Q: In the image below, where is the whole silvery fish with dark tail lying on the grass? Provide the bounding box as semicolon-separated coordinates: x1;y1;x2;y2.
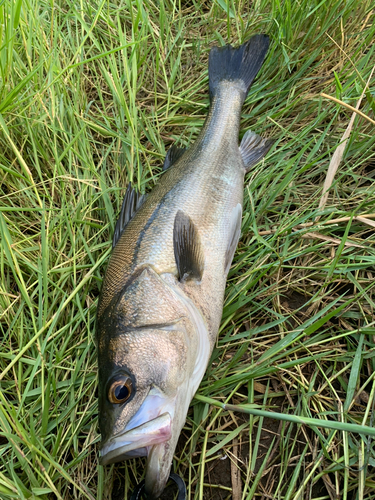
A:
96;34;273;500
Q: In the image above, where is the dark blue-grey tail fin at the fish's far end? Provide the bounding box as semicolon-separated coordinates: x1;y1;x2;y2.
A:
208;35;269;99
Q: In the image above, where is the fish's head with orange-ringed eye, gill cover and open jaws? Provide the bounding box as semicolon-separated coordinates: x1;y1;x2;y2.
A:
97;270;203;498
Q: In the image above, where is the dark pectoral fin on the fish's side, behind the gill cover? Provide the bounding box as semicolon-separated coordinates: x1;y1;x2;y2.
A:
173;210;204;282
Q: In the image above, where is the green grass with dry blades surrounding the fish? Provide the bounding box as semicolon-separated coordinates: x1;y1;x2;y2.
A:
0;0;375;500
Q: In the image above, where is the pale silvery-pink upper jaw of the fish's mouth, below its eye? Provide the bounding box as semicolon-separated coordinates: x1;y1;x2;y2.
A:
100;412;172;465
